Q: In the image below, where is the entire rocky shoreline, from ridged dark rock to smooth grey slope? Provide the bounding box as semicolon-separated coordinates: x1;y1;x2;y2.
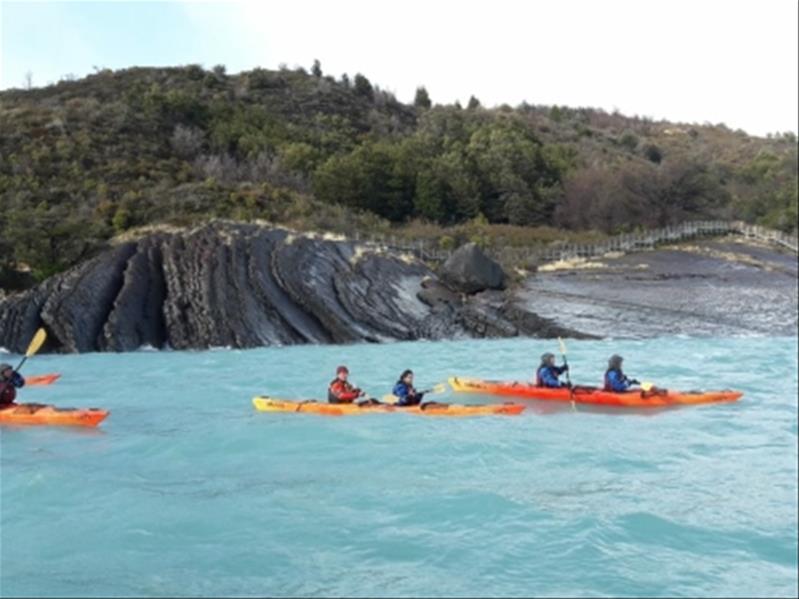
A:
0;222;797;353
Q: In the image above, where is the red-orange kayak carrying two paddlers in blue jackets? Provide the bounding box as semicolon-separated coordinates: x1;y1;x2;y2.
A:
449;377;743;408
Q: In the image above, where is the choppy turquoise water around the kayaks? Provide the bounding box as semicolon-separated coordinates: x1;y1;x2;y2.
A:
0;338;797;597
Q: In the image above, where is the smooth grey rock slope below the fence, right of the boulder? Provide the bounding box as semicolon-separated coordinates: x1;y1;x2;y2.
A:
517;238;799;338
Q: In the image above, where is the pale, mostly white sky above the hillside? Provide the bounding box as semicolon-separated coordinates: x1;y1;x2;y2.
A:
0;0;799;135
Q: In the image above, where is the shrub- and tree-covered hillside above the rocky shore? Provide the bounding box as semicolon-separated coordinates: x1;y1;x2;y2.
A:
0;64;797;286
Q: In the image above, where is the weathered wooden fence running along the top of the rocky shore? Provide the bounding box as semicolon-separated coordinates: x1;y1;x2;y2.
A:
355;221;797;264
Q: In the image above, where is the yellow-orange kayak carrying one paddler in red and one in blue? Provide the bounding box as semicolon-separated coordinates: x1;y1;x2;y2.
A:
252;397;525;416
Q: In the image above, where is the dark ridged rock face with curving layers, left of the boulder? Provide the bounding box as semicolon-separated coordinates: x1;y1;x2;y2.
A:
0;223;588;352
